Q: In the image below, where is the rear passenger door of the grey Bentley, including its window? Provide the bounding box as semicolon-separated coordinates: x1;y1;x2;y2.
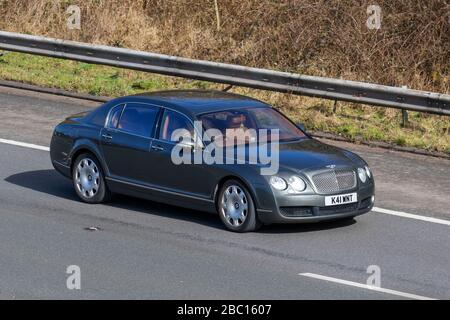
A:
101;103;160;183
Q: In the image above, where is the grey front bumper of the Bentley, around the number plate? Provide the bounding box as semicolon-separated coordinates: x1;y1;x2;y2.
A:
257;184;375;224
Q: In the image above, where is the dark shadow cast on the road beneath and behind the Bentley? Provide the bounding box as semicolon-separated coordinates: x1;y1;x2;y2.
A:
5;170;355;233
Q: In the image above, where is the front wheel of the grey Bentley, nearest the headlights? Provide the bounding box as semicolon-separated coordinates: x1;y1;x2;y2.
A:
217;180;262;232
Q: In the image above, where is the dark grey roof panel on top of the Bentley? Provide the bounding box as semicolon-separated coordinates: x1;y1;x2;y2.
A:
123;90;270;117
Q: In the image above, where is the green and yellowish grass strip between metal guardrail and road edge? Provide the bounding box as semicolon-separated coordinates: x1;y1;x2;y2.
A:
0;52;450;154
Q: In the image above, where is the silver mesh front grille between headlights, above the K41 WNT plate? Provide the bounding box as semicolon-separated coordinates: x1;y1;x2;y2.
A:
311;169;356;193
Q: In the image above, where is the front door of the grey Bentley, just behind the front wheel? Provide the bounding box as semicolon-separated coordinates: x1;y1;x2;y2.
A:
150;109;217;198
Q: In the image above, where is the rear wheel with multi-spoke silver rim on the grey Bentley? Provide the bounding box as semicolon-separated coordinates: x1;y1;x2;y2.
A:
72;153;111;203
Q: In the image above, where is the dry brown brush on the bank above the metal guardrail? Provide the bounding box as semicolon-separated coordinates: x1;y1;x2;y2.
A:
0;0;450;92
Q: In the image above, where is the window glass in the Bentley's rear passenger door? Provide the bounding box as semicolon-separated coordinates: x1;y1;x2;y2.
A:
117;103;159;137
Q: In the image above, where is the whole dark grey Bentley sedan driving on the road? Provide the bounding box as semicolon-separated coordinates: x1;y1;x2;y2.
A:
50;90;375;232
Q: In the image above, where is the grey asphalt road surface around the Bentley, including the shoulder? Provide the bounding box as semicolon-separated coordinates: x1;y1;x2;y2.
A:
0;88;450;299
